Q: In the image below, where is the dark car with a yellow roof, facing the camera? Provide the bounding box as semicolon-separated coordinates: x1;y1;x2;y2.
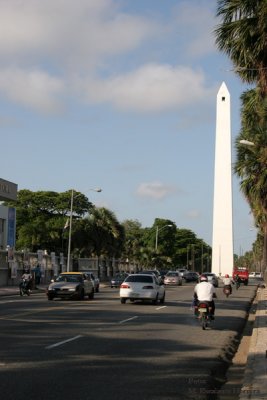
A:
46;272;95;300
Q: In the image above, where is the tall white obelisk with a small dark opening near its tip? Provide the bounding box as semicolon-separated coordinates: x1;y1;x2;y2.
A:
212;82;234;276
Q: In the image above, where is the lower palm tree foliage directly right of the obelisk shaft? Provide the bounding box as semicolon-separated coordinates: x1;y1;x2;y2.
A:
237;90;267;269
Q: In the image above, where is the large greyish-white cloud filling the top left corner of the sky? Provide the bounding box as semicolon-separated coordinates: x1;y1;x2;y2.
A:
0;0;159;67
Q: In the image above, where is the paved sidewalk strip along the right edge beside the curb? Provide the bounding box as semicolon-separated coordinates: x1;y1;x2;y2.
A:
239;288;267;400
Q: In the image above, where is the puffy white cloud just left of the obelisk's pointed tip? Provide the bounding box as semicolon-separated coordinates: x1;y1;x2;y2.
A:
87;64;216;112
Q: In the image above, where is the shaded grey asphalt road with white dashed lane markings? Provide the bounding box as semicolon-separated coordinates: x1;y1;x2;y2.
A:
0;284;256;400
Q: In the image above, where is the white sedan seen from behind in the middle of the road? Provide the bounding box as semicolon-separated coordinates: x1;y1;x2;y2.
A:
120;273;165;304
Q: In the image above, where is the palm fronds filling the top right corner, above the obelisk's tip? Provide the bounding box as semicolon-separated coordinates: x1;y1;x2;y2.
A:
215;0;267;97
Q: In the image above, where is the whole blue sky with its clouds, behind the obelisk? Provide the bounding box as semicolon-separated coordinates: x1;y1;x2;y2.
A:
0;0;256;255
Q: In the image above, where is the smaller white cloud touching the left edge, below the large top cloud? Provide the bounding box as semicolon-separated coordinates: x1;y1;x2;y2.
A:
0;68;64;113
